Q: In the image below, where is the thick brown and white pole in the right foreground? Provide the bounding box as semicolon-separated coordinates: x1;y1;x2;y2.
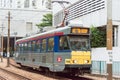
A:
107;0;113;80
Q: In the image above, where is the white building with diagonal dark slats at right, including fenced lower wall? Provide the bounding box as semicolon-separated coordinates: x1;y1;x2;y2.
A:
54;0;120;76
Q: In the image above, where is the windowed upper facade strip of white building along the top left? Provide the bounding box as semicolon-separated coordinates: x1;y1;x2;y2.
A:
0;0;51;10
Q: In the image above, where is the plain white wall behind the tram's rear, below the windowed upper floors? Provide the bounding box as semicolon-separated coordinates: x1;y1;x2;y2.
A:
0;9;51;37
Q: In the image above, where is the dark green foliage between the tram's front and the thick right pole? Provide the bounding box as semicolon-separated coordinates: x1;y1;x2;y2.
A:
91;26;106;48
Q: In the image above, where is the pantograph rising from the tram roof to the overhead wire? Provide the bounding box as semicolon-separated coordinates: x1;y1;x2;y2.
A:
52;0;70;27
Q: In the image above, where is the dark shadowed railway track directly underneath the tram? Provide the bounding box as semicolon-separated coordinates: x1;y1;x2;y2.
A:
11;64;93;80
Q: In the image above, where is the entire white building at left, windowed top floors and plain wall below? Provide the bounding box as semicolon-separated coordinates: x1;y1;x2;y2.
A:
0;0;51;51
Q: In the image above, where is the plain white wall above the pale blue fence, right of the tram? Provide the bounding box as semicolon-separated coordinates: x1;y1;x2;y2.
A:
92;47;120;61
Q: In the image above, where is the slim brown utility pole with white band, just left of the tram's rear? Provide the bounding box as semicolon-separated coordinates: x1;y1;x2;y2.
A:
7;11;10;67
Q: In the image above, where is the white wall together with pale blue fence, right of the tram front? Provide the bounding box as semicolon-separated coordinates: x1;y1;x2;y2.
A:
92;47;120;77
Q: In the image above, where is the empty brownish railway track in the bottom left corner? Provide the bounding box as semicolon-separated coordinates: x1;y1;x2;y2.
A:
0;68;31;80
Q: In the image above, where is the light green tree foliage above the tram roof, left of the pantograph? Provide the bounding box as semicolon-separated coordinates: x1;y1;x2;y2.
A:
36;14;52;28
